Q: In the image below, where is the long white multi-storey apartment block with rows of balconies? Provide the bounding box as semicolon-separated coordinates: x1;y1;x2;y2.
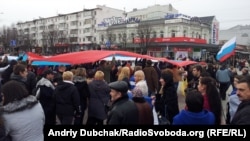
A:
17;5;124;54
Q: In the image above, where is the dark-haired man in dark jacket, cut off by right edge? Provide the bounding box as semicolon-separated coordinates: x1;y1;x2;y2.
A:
231;75;250;125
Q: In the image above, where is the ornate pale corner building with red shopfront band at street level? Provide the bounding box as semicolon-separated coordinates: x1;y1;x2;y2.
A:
98;5;219;59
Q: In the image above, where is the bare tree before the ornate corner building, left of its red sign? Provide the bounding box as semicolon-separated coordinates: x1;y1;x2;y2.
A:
137;21;152;54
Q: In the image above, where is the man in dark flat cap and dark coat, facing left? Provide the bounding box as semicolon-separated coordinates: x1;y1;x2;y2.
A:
107;81;139;125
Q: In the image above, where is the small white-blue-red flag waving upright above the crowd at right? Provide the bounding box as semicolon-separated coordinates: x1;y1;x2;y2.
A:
216;37;236;62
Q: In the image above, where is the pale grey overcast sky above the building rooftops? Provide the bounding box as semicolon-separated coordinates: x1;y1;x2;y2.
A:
0;0;250;29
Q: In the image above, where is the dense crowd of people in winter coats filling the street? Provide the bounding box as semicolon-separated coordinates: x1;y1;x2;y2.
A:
0;55;250;141
